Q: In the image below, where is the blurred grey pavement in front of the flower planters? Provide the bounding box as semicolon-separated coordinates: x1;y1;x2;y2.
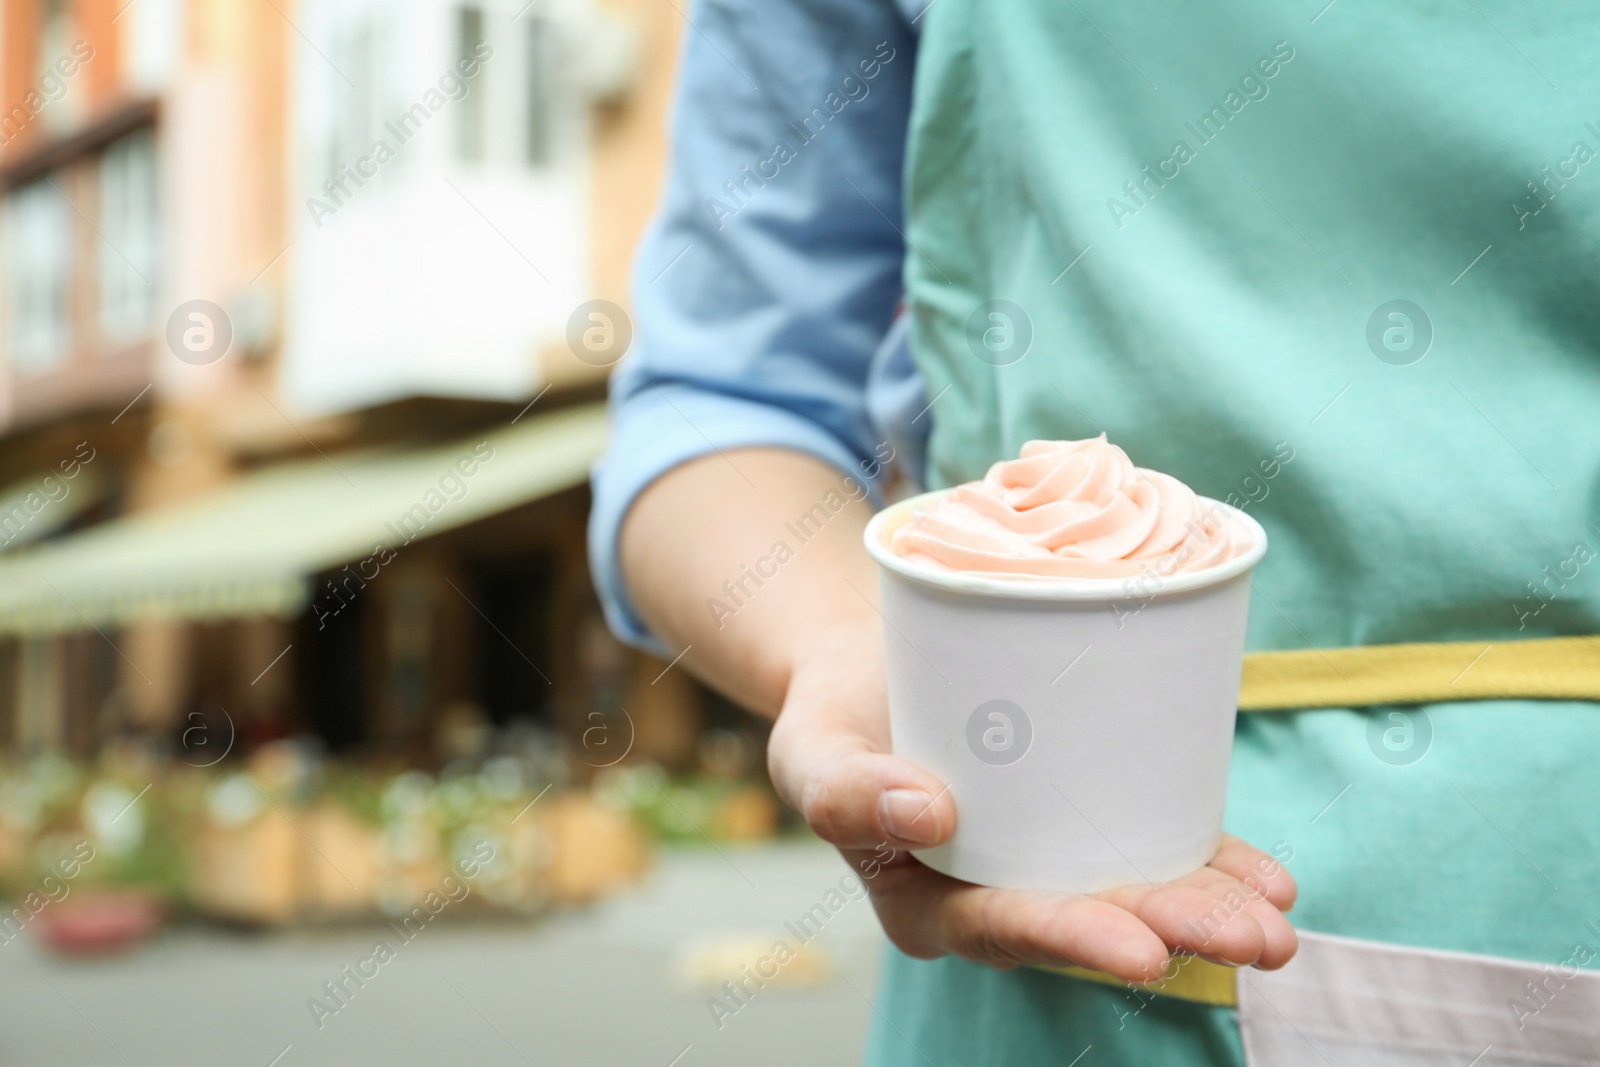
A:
0;843;882;1067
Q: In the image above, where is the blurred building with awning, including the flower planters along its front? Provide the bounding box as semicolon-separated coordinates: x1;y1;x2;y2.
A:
0;0;790;947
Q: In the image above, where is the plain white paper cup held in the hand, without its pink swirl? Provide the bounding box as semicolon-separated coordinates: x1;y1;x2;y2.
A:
866;493;1267;893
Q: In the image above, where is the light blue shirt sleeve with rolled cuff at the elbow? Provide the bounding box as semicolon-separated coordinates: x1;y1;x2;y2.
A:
589;0;915;656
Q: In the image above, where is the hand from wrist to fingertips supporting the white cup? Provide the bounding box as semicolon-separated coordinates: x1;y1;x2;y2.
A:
768;621;1298;982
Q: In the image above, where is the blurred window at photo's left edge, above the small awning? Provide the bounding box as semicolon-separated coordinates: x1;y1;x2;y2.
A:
5;178;72;374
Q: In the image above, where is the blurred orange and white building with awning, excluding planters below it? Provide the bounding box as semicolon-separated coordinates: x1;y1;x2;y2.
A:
0;0;698;761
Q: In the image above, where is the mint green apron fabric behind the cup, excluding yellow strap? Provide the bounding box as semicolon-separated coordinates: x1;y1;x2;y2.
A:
867;0;1600;1067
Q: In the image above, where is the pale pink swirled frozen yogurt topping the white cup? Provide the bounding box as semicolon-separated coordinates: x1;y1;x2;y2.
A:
890;434;1253;577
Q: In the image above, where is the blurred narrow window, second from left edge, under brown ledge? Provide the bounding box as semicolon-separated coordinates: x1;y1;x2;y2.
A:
99;128;157;341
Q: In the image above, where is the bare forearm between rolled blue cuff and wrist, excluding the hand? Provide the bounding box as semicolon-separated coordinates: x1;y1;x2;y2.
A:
619;448;880;715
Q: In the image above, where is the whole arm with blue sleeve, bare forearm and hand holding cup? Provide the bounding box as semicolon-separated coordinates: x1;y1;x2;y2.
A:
592;0;1294;981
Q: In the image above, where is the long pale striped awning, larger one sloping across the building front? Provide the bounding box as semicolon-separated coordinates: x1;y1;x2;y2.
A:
0;405;605;633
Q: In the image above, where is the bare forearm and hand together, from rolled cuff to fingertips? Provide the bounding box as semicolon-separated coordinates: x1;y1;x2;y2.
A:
621;448;1296;982
